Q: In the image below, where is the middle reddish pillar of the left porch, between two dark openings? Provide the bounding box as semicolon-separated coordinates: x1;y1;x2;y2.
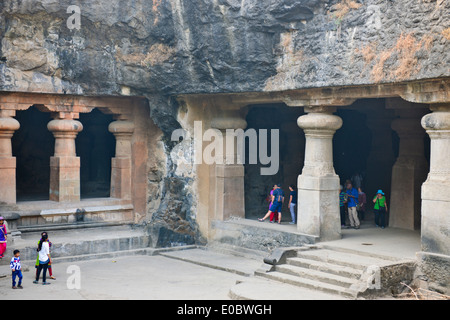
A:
47;113;83;202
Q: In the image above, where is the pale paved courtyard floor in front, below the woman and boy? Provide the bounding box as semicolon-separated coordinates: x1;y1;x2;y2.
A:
0;256;248;300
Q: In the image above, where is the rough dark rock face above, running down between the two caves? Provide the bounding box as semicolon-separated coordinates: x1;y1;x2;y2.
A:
0;0;450;242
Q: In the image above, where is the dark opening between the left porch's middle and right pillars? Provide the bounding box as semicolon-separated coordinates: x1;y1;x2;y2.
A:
75;109;116;198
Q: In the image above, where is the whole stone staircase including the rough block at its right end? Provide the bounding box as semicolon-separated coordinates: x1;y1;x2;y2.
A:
255;245;414;299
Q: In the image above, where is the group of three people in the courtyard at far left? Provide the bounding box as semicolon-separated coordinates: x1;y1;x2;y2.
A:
0;217;56;289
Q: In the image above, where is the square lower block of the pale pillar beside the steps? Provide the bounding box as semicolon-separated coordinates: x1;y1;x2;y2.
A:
297;175;341;241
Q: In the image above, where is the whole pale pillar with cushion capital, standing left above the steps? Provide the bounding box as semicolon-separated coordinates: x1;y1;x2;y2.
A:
297;107;342;241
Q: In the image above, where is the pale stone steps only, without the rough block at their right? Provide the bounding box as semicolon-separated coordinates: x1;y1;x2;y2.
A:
255;246;410;299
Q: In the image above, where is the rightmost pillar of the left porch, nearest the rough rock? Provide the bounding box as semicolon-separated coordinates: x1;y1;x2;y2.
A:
108;120;134;199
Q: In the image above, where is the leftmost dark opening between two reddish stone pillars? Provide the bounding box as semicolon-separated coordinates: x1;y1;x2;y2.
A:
11;106;55;201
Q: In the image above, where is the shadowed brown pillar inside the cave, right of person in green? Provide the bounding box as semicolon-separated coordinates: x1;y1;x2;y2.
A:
389;108;428;230
